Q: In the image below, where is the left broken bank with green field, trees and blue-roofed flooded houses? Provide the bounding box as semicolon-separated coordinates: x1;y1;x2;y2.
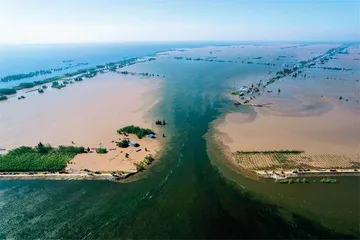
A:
0;125;165;181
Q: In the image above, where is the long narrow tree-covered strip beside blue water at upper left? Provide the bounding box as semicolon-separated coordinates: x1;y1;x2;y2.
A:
0;58;164;101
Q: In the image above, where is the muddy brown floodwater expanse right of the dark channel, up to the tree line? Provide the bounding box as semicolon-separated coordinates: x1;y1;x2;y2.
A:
215;43;360;174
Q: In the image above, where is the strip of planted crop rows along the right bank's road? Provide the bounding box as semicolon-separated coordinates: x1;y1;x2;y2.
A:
234;150;360;170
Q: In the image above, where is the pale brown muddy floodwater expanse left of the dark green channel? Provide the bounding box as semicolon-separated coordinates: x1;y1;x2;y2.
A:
0;73;163;172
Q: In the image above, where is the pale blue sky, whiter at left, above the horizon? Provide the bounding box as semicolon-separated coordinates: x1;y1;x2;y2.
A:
0;0;360;44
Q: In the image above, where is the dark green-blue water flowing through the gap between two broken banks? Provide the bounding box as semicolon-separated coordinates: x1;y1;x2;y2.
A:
0;45;359;239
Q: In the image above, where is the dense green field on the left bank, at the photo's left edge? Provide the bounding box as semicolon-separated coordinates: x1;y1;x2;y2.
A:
0;142;84;172
